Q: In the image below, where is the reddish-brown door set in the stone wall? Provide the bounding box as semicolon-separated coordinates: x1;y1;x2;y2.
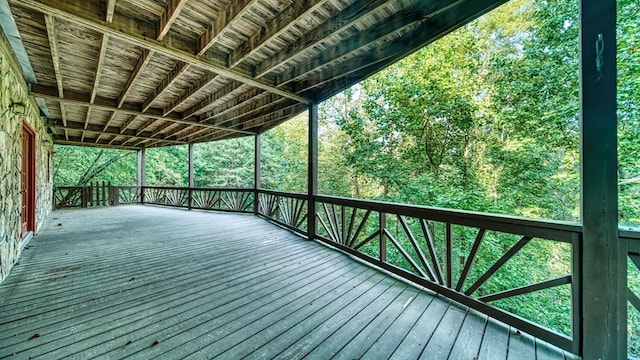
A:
20;124;36;236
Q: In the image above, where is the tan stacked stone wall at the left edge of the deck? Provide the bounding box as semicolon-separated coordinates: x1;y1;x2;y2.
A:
0;31;53;282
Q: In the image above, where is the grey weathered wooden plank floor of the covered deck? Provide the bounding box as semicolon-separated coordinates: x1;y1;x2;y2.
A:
0;206;572;359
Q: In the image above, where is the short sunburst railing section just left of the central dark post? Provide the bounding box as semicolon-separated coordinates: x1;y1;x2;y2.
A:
258;190;308;235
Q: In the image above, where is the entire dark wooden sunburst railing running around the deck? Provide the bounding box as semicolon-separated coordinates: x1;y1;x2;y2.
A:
55;186;640;353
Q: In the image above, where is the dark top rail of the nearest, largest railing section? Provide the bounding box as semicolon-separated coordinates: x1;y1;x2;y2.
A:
316;195;582;242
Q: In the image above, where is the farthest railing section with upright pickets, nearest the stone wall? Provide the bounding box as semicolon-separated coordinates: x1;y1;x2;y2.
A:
53;181;117;209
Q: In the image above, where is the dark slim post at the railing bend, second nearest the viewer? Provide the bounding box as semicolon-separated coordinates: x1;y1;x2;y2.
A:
307;104;318;240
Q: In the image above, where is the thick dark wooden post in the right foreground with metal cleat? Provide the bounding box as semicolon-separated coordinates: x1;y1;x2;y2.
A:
580;0;627;360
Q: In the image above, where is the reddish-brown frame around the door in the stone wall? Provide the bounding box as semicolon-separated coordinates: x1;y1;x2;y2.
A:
20;121;36;237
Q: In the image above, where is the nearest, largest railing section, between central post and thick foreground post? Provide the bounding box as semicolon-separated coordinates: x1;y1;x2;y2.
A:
315;196;582;353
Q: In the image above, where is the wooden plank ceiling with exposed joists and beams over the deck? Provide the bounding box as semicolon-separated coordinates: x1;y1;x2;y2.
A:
9;0;506;149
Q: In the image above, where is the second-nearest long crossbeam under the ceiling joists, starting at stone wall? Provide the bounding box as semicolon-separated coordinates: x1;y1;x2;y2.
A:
30;84;253;135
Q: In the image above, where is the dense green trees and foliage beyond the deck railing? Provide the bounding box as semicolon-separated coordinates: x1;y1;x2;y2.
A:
55;0;640;355
